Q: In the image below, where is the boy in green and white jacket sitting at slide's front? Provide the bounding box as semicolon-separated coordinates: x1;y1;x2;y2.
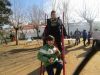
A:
38;35;63;75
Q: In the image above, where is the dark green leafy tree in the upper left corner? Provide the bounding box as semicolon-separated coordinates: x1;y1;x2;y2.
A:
0;0;12;25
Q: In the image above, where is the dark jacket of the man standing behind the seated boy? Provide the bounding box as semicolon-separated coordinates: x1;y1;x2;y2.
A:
44;18;67;42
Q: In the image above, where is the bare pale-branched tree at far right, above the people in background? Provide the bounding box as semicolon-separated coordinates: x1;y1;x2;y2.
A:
78;1;98;32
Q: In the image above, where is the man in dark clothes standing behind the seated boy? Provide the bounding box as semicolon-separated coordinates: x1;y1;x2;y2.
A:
44;10;67;53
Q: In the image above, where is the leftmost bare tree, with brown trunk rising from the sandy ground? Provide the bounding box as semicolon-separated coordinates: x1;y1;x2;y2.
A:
10;2;24;45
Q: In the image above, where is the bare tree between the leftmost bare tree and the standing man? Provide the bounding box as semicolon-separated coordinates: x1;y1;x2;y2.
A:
29;5;45;38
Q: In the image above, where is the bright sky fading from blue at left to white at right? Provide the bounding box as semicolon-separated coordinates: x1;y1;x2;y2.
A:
10;0;100;21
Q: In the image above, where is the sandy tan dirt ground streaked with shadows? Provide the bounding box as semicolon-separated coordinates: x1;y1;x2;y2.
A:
0;41;100;75
